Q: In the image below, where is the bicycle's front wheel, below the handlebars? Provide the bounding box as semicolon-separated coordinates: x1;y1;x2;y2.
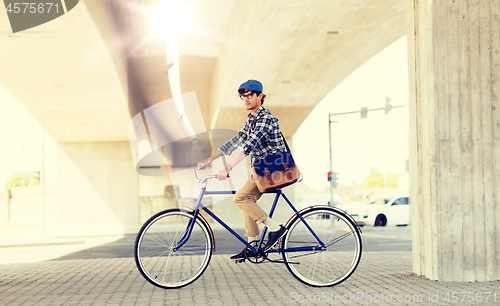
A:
134;209;213;289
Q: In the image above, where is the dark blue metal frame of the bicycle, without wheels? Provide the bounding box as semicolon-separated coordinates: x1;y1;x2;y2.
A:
173;185;327;253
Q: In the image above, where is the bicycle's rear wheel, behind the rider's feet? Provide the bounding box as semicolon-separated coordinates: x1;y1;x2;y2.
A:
282;207;361;287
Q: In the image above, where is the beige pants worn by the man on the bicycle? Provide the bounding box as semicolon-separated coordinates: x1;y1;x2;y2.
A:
233;176;267;237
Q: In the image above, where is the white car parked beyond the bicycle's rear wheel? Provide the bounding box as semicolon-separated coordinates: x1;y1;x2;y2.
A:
339;195;411;226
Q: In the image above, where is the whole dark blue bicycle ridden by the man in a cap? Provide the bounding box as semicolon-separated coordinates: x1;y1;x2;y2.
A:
134;169;362;289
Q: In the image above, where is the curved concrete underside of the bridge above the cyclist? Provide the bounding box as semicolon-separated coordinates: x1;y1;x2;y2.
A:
0;0;405;142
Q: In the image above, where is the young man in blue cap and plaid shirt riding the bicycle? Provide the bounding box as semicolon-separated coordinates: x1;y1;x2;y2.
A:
198;80;287;259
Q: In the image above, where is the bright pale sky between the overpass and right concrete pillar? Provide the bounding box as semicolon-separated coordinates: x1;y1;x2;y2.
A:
293;36;409;190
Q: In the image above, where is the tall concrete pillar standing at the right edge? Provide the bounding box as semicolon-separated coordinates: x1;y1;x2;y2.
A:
407;0;500;281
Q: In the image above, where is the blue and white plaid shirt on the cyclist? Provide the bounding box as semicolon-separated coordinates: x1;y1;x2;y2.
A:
219;105;286;163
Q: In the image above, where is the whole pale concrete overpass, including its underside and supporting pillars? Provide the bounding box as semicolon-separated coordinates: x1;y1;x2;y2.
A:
0;0;500;280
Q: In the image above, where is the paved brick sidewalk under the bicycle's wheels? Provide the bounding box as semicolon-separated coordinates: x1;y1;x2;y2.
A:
0;252;500;305
